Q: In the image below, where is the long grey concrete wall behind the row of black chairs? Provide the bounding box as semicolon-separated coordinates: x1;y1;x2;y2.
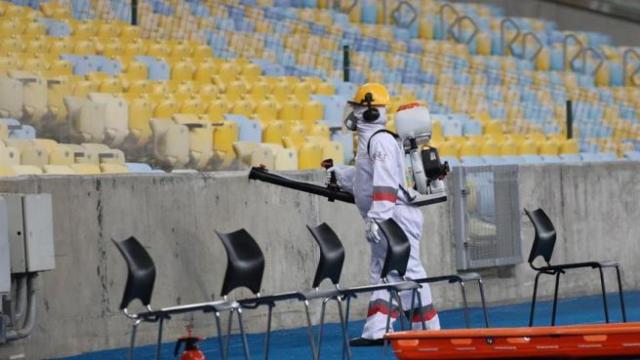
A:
0;163;640;359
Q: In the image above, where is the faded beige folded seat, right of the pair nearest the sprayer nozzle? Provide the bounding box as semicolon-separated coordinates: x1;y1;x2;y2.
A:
172;114;213;169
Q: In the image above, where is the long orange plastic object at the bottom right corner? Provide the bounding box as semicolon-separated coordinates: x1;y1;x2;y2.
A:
386;322;640;360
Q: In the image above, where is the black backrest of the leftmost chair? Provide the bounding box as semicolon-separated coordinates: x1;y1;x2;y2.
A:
114;236;156;310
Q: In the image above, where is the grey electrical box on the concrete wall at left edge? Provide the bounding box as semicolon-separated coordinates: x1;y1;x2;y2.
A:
0;194;55;273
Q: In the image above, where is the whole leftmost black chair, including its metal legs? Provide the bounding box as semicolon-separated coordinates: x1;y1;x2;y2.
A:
114;237;228;359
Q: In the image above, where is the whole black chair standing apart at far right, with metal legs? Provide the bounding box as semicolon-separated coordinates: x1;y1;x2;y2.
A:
524;209;627;326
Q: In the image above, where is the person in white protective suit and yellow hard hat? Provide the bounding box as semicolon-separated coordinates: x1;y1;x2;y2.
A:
328;83;440;346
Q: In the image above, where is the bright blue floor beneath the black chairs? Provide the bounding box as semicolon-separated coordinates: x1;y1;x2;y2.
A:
58;291;640;360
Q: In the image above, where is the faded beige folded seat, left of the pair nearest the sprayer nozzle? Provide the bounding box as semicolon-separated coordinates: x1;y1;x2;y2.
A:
151;119;189;167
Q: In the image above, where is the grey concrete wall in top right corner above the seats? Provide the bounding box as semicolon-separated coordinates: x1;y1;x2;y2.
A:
456;0;640;46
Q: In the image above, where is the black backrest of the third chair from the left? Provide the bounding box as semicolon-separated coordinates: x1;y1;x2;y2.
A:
307;223;344;288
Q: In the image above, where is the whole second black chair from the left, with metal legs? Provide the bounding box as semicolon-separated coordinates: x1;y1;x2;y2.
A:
216;229;347;359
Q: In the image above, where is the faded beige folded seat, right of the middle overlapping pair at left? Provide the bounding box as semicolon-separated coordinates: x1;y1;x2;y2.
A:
88;93;129;146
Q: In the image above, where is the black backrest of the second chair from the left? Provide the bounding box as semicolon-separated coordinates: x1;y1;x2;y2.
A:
216;229;264;296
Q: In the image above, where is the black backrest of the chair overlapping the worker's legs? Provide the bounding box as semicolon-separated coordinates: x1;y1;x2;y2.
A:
378;218;411;278
